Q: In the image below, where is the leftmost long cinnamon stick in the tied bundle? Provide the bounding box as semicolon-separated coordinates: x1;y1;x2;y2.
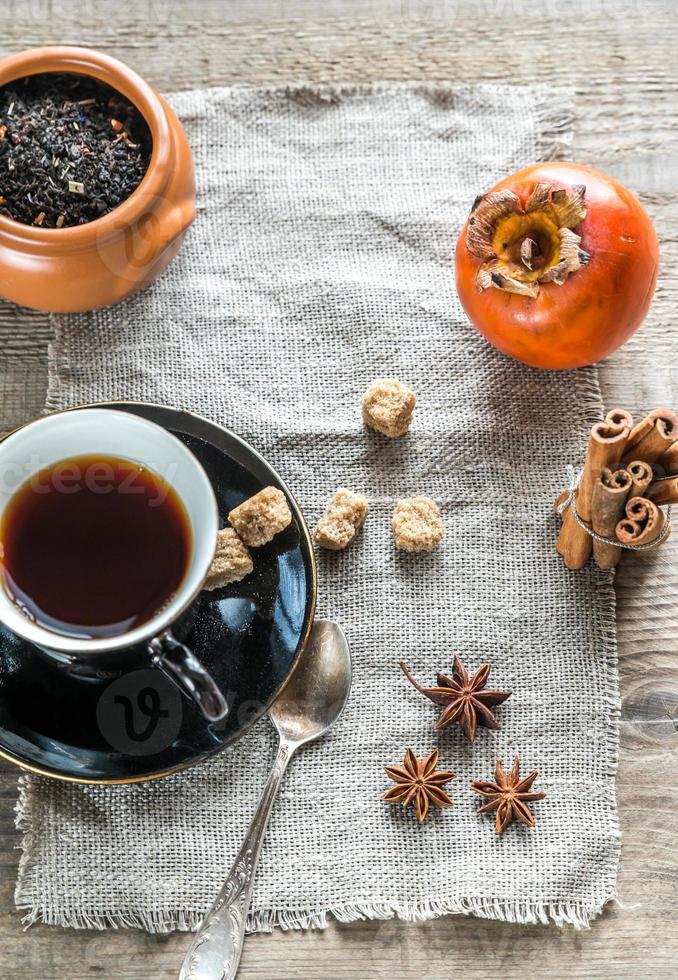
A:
556;421;629;569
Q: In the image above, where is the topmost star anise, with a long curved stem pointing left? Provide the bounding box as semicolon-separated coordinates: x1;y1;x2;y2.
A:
400;656;513;742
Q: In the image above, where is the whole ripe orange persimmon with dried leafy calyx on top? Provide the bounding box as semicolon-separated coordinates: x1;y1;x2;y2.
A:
456;162;659;369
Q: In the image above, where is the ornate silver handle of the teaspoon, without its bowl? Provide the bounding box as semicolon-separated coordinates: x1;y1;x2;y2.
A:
179;742;294;980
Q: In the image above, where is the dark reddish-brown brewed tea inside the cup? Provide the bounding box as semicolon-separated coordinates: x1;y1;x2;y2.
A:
0;455;191;639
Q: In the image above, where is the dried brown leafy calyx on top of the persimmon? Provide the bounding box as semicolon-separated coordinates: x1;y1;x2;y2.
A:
466;181;591;299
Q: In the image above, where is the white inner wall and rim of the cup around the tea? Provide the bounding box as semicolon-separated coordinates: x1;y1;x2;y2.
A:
0;408;219;653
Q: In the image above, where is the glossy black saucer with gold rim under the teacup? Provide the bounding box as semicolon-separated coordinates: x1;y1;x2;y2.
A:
0;402;316;783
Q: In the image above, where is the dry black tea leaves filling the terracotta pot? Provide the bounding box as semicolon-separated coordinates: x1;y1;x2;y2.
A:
0;73;151;228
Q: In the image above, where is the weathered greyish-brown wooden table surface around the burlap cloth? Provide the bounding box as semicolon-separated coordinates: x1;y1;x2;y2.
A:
0;0;678;980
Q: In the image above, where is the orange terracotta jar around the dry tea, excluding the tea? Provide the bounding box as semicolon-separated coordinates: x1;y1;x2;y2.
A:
0;47;195;313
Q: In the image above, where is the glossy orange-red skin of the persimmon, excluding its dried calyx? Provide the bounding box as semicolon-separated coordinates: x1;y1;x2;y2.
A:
456;163;659;370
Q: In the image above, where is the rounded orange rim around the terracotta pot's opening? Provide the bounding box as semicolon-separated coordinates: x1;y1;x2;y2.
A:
0;44;171;251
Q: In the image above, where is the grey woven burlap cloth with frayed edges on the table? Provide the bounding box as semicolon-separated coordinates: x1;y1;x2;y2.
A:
16;84;619;931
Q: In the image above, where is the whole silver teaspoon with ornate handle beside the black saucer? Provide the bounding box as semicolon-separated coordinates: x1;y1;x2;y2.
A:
179;619;351;980
